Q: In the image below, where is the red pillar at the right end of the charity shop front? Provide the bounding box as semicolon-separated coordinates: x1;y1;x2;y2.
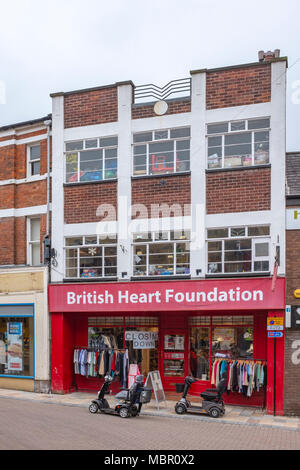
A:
266;311;284;416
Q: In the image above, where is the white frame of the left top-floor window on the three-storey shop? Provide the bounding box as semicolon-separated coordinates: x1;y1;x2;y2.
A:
64;135;119;185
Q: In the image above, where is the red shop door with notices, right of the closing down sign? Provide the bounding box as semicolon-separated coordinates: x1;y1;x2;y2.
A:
160;328;188;391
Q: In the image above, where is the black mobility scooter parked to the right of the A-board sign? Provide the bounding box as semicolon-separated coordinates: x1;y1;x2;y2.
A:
175;373;227;418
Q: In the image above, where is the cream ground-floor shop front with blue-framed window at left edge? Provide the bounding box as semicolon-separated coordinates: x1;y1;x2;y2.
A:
0;267;50;392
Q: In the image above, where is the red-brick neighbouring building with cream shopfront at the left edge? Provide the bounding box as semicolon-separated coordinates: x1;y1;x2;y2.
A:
0;116;51;392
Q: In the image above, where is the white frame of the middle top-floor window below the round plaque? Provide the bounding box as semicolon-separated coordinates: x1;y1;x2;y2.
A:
131;126;191;178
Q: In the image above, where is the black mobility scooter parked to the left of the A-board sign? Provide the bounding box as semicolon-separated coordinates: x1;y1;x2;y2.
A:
89;375;152;418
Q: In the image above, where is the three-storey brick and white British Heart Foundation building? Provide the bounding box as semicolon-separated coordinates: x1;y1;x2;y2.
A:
49;51;287;414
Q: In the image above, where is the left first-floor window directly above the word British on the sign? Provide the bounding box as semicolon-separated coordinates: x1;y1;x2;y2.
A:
65;235;117;279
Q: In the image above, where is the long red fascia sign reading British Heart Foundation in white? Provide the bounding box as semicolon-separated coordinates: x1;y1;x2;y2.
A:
49;278;285;313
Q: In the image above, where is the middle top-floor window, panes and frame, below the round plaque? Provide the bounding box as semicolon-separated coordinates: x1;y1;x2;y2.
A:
133;127;190;176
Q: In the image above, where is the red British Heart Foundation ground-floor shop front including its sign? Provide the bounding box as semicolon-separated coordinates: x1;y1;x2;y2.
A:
49;278;285;414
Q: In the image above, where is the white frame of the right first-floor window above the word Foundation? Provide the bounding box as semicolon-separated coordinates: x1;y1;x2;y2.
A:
206;224;271;276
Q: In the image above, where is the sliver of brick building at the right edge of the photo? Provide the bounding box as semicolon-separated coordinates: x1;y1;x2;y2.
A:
284;152;300;415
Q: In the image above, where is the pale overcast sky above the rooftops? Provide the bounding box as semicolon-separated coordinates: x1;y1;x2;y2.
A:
0;0;300;151
